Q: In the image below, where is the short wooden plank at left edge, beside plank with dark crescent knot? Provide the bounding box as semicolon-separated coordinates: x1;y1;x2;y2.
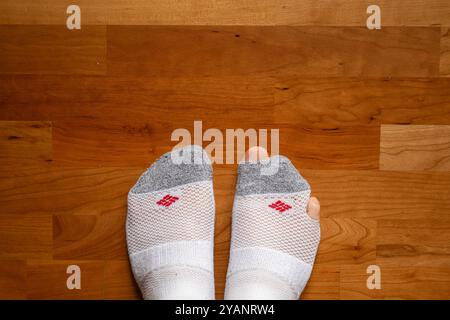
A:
0;214;52;260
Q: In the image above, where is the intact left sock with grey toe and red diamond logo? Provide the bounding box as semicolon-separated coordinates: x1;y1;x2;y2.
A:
126;146;214;300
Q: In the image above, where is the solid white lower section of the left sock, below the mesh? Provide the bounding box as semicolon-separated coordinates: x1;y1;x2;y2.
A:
130;241;214;300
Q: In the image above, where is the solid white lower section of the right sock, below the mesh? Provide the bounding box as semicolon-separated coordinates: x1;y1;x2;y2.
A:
225;247;312;300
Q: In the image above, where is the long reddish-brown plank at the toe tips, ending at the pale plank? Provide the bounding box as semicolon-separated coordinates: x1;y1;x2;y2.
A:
53;119;379;169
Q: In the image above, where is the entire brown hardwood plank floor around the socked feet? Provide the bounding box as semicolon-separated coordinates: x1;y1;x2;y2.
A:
0;0;450;299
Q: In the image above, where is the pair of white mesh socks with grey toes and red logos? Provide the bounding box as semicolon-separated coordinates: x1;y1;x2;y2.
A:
126;146;320;300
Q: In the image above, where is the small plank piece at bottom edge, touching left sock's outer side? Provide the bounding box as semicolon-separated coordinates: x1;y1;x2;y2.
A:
104;260;142;300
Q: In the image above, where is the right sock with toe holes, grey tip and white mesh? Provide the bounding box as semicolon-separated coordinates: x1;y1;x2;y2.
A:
225;156;320;300
